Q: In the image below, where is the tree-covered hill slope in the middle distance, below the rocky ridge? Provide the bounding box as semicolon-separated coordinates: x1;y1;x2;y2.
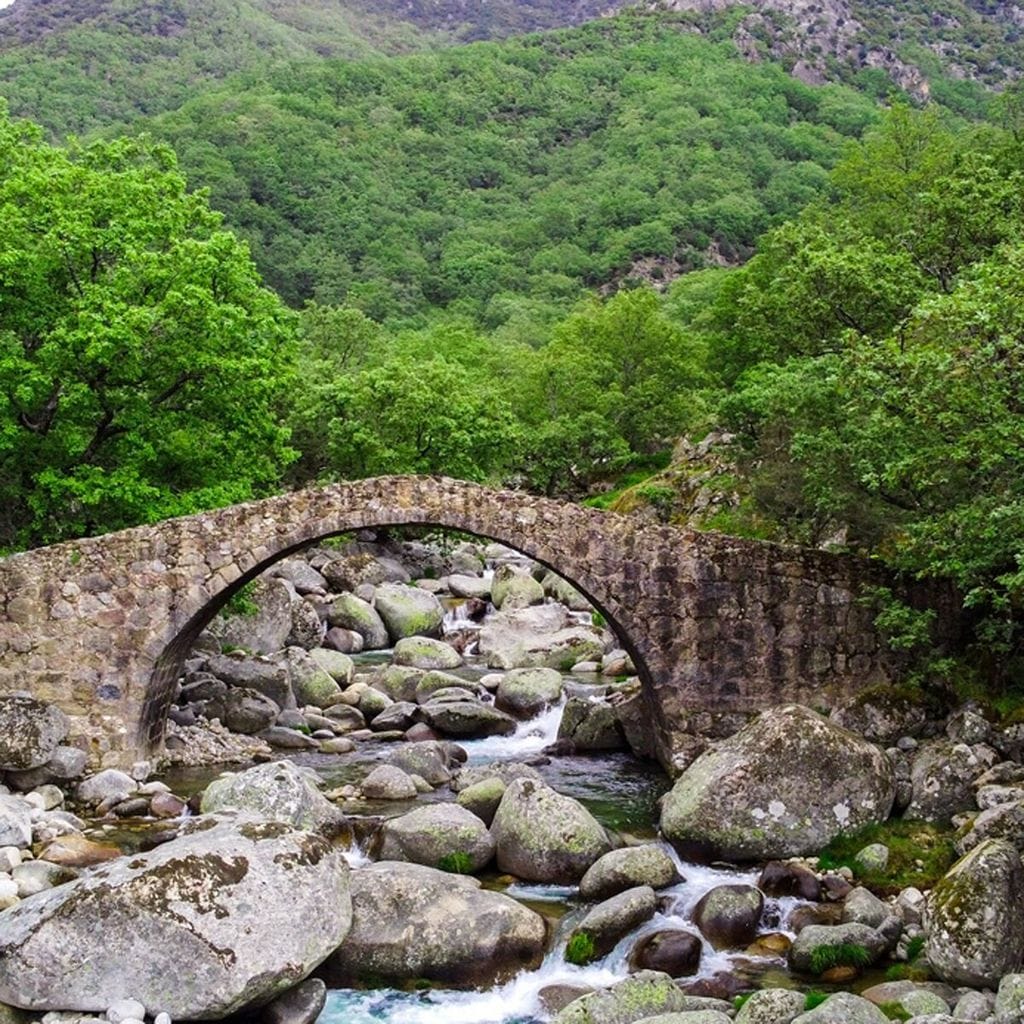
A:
147;16;876;315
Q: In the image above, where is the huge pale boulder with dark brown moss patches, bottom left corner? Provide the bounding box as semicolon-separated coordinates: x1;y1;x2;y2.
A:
0;819;352;1020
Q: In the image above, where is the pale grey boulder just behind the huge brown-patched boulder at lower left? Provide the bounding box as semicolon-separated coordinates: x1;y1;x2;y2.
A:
201;761;343;833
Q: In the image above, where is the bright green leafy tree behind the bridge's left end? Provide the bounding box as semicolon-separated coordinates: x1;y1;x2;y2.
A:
0;109;293;549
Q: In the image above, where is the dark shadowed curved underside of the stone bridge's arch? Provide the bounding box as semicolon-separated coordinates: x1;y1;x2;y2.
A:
137;520;652;753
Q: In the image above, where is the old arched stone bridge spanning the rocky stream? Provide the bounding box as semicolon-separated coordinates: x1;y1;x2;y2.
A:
0;476;950;766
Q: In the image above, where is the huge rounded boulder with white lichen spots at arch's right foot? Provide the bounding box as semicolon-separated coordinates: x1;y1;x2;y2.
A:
662;705;895;860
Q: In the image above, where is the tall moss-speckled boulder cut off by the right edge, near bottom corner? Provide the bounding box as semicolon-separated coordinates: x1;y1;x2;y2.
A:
925;840;1024;988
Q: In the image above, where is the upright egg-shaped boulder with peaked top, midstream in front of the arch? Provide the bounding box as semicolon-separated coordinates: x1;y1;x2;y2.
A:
490;778;611;884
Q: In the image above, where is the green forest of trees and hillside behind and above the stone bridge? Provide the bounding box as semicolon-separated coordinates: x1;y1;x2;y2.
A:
0;5;1024;679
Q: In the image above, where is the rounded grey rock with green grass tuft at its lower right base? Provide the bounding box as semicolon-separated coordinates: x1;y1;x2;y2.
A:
380;804;495;873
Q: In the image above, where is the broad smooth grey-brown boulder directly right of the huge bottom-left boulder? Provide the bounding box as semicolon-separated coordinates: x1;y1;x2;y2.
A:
325;861;546;985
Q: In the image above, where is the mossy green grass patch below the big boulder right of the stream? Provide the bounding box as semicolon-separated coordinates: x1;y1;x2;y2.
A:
819;818;956;895
